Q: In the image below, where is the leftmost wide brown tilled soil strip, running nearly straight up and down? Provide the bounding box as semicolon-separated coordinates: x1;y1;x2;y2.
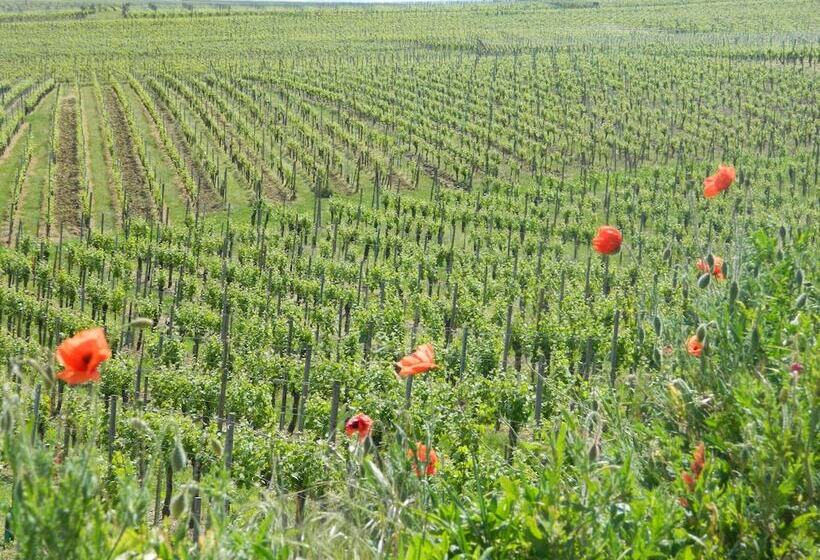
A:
54;97;83;234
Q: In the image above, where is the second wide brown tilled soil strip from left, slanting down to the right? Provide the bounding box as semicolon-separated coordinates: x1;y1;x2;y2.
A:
104;88;154;220
